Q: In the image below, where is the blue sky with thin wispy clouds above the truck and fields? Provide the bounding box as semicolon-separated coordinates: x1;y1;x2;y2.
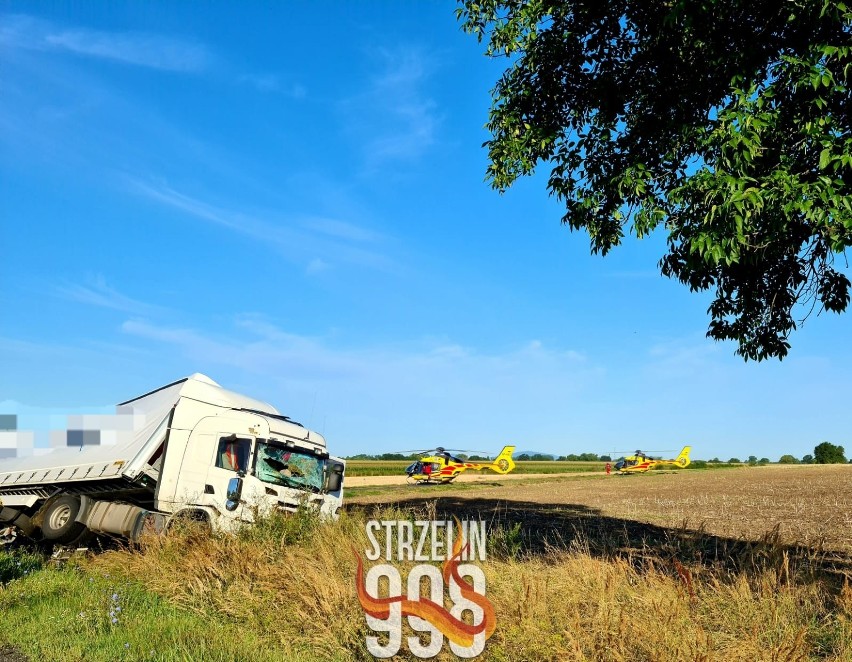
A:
0;1;852;459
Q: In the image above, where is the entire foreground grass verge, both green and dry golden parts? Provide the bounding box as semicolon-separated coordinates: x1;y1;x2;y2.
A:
0;477;852;662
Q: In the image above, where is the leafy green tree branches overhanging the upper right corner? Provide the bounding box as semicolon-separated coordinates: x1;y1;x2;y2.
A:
456;0;852;360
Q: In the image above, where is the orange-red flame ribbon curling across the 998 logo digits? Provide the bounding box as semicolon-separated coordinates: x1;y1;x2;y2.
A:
352;519;497;647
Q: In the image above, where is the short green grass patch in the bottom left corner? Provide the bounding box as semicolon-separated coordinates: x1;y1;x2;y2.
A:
0;550;304;662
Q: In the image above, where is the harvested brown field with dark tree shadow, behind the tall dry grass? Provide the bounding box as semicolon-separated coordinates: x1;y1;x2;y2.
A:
346;465;852;572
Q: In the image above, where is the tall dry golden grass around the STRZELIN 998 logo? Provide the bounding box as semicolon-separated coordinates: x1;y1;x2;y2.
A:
89;508;852;662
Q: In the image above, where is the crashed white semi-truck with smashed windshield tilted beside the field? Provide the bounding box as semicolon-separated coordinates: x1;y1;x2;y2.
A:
0;373;345;545
